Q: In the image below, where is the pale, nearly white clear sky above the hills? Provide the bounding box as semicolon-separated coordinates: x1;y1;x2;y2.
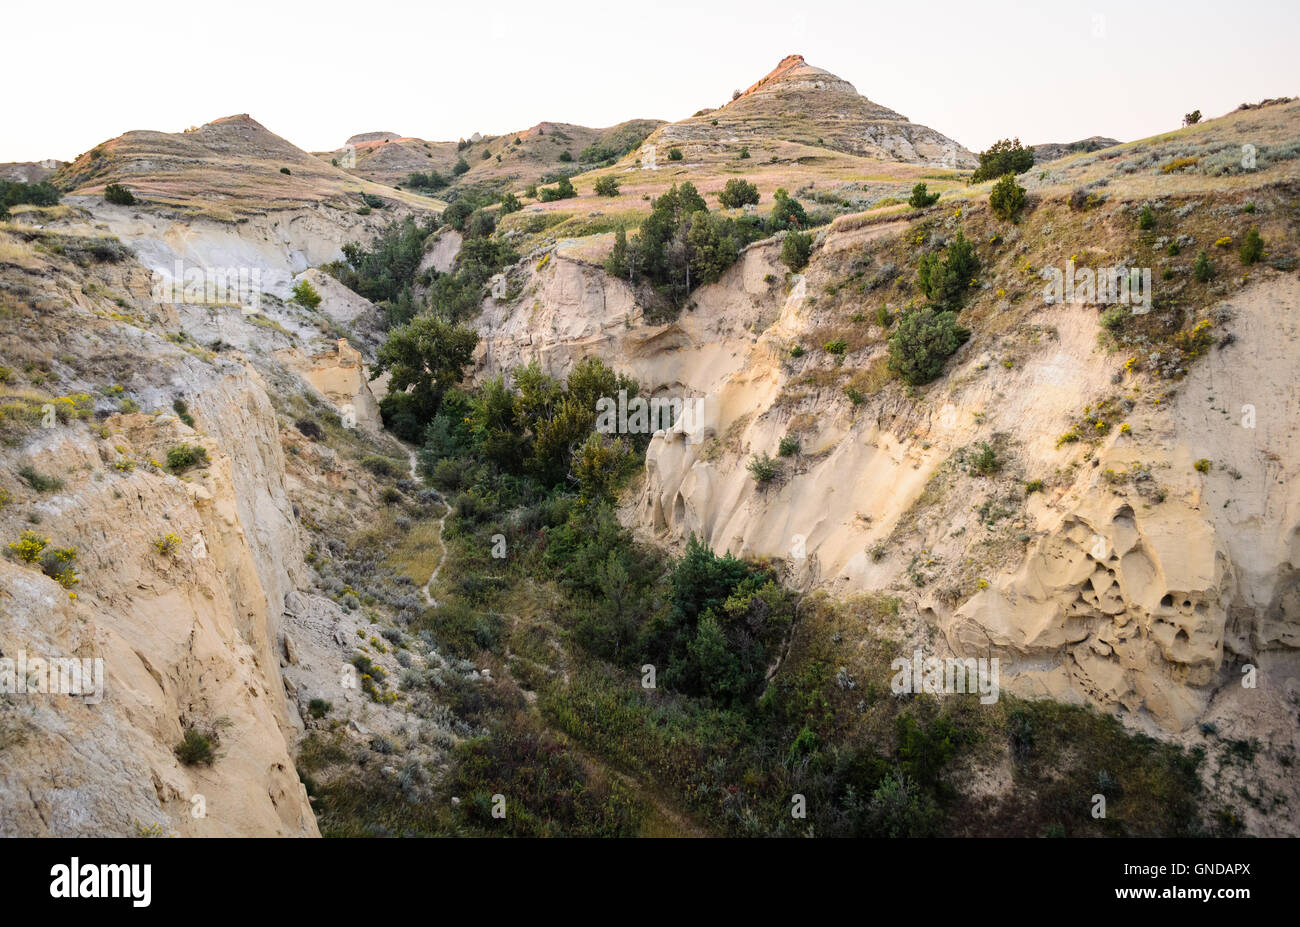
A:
0;0;1300;161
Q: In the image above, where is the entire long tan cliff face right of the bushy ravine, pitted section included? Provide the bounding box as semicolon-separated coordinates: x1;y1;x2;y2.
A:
480;218;1300;732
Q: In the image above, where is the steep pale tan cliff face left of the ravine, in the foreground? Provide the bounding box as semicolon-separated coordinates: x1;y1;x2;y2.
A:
0;365;317;836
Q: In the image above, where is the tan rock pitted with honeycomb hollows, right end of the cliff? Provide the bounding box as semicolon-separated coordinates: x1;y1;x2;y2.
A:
945;280;1300;729
